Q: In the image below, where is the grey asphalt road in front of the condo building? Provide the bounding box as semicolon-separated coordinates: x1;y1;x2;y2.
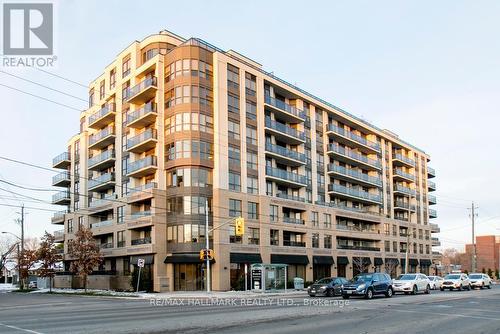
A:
0;287;500;334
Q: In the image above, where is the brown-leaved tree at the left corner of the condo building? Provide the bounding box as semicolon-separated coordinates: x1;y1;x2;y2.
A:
68;226;103;292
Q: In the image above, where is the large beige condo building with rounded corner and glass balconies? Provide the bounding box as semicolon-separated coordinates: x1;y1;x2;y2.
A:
52;31;439;291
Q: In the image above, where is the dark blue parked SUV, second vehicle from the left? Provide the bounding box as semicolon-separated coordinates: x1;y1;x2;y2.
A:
342;273;394;299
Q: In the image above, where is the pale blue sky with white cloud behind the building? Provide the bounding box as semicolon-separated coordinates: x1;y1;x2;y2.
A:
0;0;500;249
